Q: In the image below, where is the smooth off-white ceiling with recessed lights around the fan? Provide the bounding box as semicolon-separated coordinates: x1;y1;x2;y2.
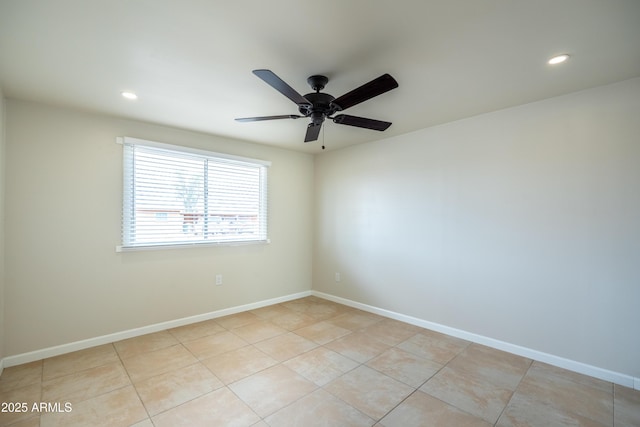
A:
0;0;640;153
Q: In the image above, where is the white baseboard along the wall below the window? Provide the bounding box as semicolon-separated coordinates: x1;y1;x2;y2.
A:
0;291;311;371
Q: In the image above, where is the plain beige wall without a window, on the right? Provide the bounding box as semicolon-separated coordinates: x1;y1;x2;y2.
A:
313;79;640;378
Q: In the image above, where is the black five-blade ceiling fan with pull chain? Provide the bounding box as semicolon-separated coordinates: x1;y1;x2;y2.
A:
236;70;398;142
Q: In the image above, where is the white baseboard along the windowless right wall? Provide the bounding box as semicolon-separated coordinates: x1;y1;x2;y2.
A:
311;291;640;390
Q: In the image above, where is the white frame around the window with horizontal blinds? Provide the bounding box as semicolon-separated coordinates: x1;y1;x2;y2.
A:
116;137;271;252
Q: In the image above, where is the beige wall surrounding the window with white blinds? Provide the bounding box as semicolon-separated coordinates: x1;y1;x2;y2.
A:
5;100;313;356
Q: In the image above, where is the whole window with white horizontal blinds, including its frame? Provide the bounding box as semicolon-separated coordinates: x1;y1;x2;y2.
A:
118;137;270;250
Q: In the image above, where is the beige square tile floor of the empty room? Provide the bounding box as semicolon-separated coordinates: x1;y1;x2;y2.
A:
0;297;640;427
